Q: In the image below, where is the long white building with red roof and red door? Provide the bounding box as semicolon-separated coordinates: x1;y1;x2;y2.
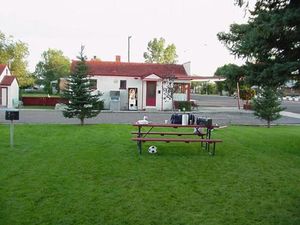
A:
72;56;191;110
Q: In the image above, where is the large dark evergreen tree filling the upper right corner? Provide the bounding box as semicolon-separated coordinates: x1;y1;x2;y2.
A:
218;0;300;87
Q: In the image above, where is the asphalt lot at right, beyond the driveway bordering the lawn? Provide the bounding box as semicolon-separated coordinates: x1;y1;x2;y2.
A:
191;94;300;113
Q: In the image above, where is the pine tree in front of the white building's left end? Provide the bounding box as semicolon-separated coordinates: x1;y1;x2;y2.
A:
63;46;103;125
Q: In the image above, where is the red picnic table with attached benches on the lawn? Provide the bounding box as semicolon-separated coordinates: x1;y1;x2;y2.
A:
131;123;222;155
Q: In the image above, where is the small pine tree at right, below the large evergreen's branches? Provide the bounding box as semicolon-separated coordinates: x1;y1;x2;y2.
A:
253;87;284;128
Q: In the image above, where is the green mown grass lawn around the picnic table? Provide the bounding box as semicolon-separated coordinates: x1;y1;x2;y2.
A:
0;125;300;225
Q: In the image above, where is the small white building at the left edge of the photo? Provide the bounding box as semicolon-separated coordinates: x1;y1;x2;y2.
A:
0;64;19;108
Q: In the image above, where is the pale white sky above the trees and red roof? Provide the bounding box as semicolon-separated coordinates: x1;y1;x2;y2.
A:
0;0;254;76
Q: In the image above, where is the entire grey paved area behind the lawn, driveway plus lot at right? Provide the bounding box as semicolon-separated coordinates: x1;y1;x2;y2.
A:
0;95;300;125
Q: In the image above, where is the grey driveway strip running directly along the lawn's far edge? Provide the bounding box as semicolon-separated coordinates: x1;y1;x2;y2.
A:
0;107;300;125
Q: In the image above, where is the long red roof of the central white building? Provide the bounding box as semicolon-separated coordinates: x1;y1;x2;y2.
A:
72;60;189;79
